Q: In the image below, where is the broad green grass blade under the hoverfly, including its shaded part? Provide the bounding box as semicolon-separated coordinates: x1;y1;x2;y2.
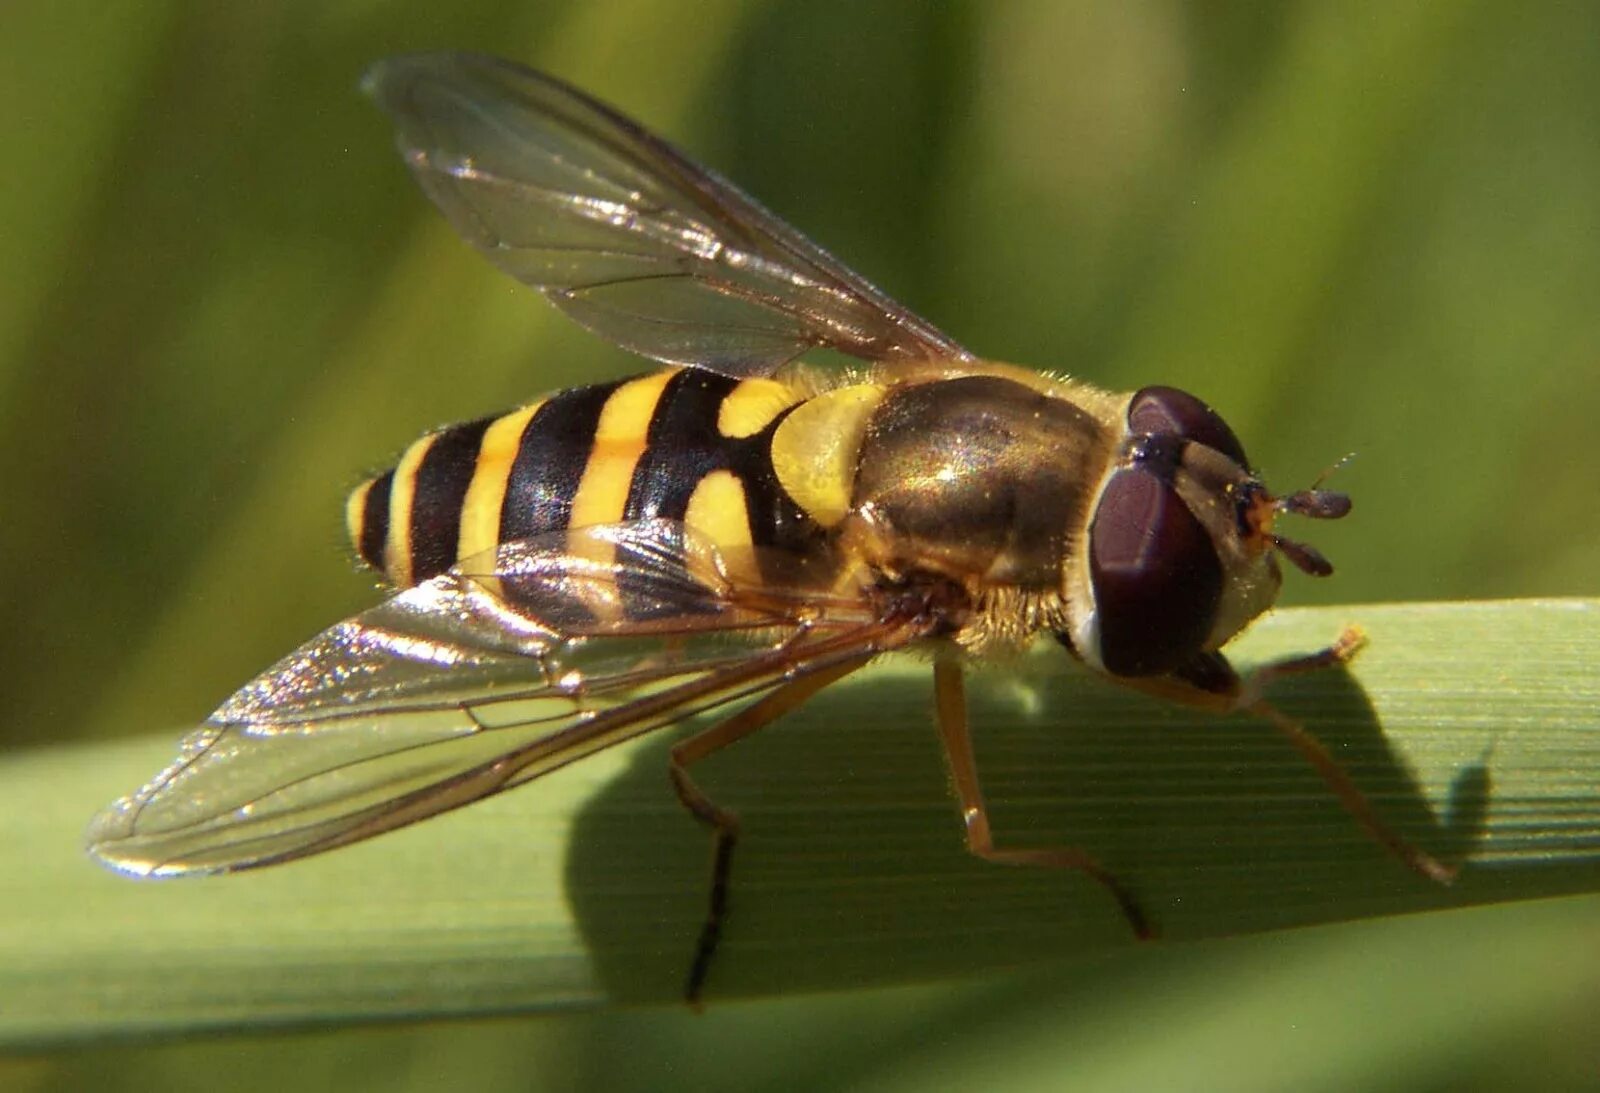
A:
0;600;1600;1045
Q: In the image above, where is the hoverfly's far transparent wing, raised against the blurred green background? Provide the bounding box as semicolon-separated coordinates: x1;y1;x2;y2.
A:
363;53;970;376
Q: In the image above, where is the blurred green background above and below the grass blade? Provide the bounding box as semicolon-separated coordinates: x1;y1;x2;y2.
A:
0;0;1600;1090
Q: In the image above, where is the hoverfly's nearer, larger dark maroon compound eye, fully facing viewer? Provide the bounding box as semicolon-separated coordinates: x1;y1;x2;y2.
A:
1090;460;1222;675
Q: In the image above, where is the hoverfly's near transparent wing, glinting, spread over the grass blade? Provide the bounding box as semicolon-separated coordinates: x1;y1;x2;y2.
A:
88;520;920;875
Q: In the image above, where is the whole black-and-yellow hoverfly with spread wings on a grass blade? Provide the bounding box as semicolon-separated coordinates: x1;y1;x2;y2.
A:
88;54;1451;1000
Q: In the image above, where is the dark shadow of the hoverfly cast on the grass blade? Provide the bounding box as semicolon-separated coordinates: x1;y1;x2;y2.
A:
566;652;1490;1000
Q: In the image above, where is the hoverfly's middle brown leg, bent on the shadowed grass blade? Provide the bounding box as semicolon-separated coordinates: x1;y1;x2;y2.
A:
933;659;1155;938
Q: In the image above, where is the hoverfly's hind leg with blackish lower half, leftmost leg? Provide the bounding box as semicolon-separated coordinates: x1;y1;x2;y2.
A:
667;656;872;1008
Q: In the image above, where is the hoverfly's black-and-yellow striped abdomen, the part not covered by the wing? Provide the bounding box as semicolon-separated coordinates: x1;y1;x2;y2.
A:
346;370;824;586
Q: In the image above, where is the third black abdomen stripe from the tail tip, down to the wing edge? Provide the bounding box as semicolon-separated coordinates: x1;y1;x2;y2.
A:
499;382;622;542
